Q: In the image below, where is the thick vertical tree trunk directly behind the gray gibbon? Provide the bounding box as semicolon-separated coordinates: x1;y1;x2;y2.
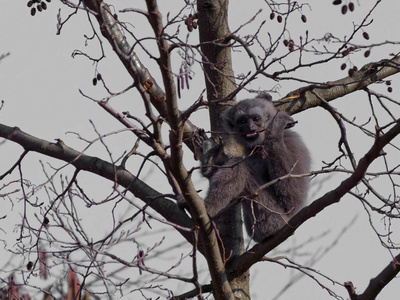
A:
197;0;250;299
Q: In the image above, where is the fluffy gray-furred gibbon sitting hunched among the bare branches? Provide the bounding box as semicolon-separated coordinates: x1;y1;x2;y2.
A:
202;96;310;242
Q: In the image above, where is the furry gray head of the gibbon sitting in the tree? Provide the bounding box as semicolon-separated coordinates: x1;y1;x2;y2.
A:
223;94;277;149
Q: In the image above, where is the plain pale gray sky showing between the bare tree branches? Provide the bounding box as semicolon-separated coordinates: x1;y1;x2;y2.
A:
0;0;400;300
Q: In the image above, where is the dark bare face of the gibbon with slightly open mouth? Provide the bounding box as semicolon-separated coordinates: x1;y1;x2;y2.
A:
236;112;268;148
